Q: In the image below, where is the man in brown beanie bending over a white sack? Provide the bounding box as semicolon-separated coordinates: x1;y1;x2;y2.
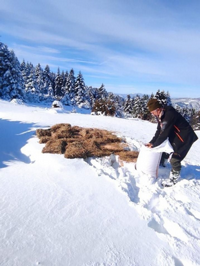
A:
146;98;198;187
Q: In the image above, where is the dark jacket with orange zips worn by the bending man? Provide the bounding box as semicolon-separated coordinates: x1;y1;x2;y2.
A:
150;106;198;160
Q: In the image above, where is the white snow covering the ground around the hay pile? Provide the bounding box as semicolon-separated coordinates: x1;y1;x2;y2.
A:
0;100;200;266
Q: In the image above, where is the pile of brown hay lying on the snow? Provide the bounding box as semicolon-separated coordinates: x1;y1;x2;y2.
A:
36;124;138;162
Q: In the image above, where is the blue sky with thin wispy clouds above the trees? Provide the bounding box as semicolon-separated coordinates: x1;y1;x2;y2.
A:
0;0;200;97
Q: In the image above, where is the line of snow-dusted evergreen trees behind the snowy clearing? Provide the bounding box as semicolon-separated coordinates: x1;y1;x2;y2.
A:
0;42;200;129
